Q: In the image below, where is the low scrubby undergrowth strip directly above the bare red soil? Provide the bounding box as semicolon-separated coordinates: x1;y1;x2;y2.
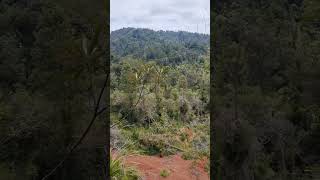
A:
112;117;209;160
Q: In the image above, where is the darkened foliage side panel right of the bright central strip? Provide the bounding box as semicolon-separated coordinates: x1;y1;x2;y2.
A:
210;0;320;180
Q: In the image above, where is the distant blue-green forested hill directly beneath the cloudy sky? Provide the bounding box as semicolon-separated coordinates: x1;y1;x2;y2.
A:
110;28;210;64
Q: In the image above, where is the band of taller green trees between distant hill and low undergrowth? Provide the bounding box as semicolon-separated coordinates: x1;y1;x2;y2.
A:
111;54;209;124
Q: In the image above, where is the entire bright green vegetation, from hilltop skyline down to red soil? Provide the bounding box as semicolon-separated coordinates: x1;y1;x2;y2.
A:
111;28;210;175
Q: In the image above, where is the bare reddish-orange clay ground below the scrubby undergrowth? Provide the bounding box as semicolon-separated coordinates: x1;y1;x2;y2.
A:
124;155;209;180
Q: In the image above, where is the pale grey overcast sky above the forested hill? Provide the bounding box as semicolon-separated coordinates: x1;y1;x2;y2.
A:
110;0;210;34
